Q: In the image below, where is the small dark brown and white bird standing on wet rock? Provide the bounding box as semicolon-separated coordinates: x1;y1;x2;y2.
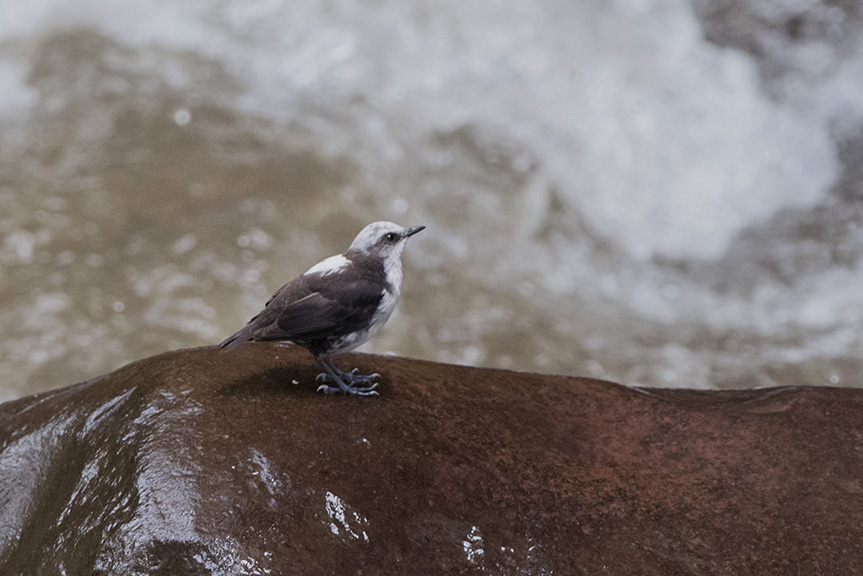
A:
219;222;425;396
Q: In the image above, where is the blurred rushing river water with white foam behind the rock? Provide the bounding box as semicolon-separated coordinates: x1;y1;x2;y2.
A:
0;0;863;400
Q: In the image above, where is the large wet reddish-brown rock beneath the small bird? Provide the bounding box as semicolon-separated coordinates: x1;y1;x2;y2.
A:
0;344;863;576
